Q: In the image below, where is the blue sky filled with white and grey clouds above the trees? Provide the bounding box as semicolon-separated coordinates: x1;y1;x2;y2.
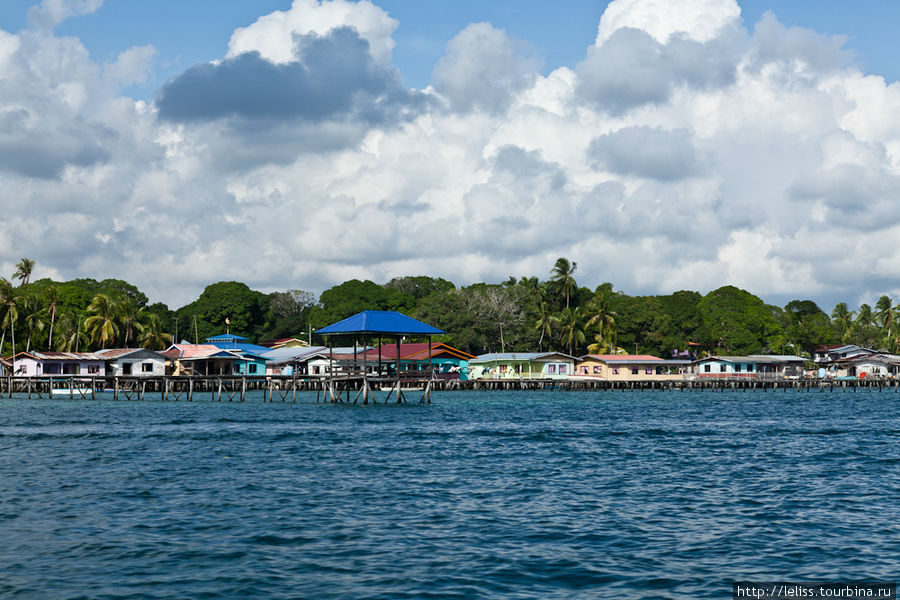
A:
0;0;900;311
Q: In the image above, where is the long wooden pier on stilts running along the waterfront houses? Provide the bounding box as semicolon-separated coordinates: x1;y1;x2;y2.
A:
0;372;900;404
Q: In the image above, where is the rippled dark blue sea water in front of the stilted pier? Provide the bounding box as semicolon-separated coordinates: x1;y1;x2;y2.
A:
0;391;900;599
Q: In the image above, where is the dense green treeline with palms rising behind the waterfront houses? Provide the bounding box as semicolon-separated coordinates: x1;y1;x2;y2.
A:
0;258;900;357
